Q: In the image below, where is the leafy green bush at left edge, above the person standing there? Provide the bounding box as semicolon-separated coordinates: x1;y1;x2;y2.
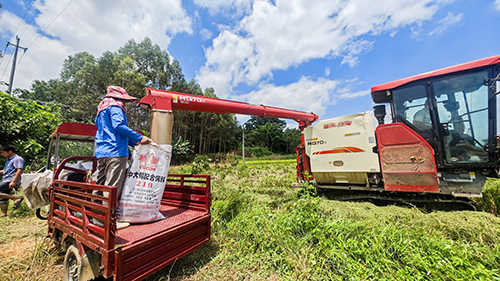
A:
0;92;60;165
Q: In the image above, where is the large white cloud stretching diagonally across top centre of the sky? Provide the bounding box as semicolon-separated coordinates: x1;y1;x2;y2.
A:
195;0;453;97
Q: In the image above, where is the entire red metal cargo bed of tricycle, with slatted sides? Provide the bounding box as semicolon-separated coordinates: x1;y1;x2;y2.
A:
49;157;211;280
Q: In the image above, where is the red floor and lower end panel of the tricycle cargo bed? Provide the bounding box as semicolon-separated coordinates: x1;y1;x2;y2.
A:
114;205;210;280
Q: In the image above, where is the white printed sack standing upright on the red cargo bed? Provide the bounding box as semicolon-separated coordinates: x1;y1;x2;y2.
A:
117;144;172;223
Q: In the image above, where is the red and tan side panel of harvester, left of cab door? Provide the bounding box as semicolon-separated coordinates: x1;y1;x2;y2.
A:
376;123;439;192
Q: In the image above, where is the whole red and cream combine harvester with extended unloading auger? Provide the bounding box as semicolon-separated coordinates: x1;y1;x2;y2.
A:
139;56;500;206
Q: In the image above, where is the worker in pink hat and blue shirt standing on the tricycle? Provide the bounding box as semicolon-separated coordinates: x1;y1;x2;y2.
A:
95;86;151;200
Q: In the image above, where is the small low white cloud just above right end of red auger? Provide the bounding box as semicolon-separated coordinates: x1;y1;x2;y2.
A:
233;76;370;115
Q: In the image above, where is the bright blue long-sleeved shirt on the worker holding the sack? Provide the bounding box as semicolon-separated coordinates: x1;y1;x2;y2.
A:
95;106;142;159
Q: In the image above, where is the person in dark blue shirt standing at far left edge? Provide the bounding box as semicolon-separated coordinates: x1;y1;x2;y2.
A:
0;145;24;217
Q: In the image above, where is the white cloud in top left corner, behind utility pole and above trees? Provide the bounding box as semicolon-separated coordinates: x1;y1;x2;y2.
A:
0;0;193;91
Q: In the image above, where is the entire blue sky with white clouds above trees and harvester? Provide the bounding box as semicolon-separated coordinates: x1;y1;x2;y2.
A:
0;0;500;123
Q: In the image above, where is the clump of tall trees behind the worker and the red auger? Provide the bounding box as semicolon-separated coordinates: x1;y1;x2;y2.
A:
15;38;241;159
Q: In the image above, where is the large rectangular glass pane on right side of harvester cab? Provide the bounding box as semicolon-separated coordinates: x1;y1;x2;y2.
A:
433;71;488;163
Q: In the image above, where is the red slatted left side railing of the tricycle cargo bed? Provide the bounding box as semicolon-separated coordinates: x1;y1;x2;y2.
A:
49;156;117;250
